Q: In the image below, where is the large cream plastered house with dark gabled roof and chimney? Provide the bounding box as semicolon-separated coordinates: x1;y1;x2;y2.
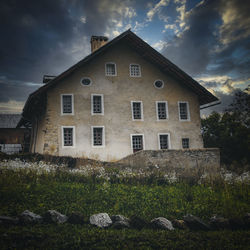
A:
18;30;218;161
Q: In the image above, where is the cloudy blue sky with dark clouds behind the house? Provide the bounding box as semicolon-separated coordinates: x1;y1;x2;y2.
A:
0;0;250;115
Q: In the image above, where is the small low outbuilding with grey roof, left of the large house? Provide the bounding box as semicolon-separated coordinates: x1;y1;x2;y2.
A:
0;114;30;154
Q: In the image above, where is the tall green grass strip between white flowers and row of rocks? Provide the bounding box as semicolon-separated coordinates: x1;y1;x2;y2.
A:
0;170;250;220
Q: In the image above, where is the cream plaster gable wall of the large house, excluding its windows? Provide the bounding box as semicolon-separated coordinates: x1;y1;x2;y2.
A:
34;40;203;161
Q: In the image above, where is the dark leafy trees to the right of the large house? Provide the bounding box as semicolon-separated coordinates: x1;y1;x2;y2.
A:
201;91;250;167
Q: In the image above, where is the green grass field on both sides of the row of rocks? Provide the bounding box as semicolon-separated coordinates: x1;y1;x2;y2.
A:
0;167;250;249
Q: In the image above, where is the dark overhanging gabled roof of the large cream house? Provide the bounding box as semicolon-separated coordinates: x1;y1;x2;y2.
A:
18;29;218;125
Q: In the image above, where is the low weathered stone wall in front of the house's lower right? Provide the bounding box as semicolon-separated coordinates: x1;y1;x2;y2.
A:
118;148;220;177
